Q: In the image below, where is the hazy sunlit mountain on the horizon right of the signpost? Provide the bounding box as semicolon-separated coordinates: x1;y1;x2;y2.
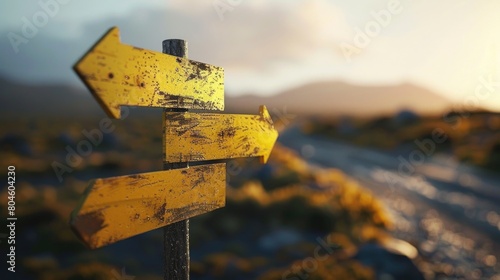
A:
226;82;451;116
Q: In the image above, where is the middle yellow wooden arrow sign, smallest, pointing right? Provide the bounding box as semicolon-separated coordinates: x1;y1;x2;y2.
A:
163;106;278;163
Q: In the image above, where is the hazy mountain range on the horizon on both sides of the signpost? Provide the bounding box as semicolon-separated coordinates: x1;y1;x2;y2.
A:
0;77;450;118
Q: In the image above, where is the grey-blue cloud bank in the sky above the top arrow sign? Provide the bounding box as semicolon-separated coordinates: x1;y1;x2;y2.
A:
0;0;352;87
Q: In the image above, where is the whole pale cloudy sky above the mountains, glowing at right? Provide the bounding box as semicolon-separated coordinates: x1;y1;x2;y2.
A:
0;0;500;111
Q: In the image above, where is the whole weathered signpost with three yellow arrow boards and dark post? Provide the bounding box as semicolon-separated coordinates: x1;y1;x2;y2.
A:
70;27;278;279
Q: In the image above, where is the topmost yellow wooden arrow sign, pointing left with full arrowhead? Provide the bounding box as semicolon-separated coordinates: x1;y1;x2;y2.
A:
74;27;224;118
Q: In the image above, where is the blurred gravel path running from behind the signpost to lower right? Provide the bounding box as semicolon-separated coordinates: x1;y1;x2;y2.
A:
280;128;500;280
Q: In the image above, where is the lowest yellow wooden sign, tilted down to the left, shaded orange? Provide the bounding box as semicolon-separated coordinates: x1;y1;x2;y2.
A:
70;163;226;248
